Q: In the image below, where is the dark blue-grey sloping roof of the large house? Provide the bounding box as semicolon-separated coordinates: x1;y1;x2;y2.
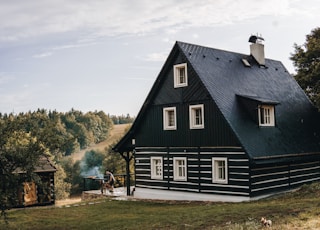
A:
177;42;320;159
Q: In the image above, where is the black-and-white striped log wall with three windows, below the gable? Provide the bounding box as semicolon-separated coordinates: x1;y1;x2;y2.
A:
135;148;250;196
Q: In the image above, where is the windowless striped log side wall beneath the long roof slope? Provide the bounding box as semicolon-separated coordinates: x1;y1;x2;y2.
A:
251;161;320;197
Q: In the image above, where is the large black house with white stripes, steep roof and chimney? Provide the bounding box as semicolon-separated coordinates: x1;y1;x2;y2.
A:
114;36;320;201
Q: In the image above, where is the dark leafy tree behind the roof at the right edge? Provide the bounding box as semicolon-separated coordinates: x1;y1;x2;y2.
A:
290;27;320;109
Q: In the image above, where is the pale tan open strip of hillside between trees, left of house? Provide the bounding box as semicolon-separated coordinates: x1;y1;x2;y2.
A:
71;124;131;162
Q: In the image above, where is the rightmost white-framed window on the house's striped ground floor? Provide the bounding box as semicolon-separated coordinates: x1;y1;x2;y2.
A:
212;157;228;184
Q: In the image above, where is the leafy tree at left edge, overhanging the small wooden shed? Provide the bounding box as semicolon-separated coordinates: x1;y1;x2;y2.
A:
0;120;48;217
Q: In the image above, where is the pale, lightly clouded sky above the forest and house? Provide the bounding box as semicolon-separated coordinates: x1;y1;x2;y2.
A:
0;0;320;116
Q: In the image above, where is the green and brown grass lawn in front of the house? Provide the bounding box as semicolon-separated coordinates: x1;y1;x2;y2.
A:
0;183;320;230
